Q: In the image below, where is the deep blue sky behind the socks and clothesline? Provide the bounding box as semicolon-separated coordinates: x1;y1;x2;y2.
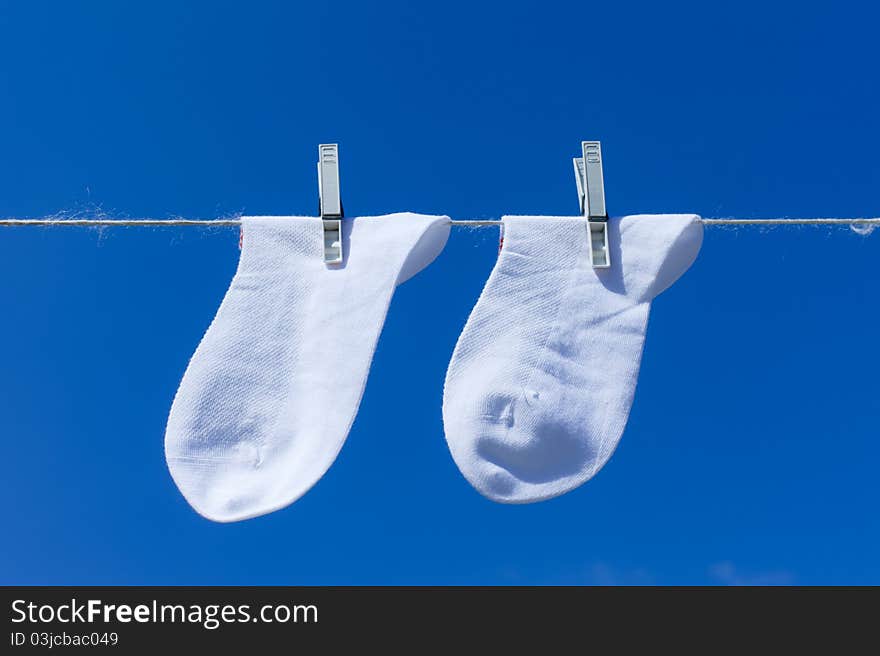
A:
0;0;880;584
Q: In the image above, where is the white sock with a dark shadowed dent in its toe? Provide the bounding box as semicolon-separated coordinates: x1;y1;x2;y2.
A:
443;215;703;503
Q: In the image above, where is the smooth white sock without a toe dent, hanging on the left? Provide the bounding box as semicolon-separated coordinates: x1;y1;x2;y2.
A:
165;213;450;522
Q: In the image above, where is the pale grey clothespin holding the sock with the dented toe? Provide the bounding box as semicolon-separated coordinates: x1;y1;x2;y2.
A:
574;141;611;269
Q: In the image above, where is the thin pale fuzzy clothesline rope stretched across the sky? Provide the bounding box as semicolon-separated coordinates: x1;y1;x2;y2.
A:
0;217;880;228
